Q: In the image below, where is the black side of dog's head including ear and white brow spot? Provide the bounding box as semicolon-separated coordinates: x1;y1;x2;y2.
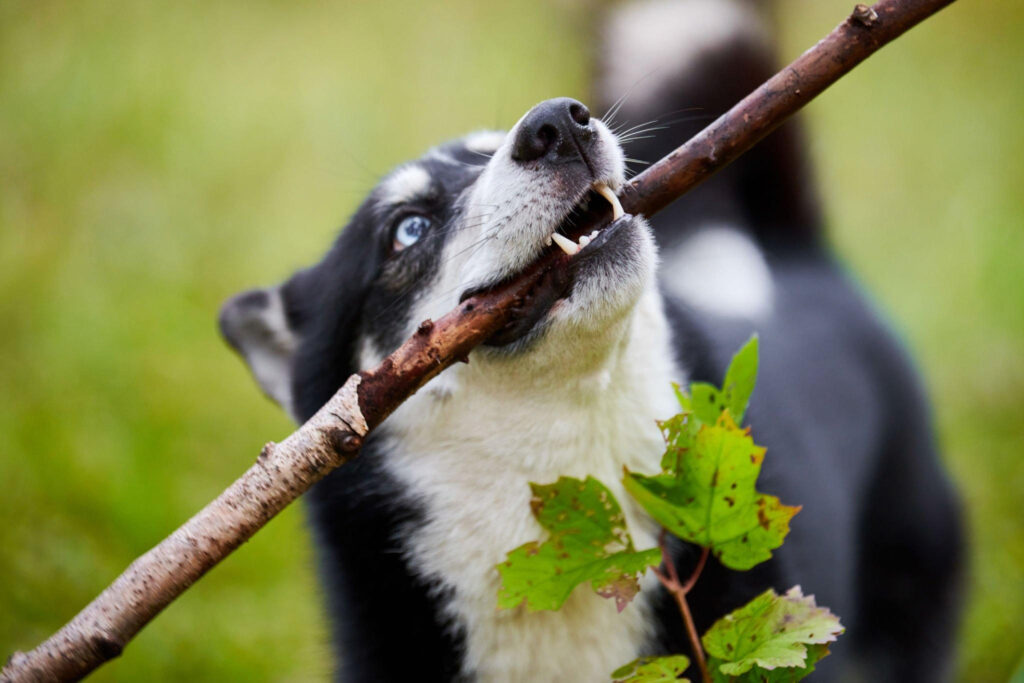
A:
220;133;504;421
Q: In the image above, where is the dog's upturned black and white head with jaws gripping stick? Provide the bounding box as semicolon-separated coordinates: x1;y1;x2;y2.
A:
220;97;655;420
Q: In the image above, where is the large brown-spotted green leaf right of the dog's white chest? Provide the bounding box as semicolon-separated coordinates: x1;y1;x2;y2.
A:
623;412;800;569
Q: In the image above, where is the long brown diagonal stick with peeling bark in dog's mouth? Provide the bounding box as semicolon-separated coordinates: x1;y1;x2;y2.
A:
0;0;953;681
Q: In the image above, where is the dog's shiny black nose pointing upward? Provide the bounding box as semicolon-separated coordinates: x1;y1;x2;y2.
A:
512;97;594;163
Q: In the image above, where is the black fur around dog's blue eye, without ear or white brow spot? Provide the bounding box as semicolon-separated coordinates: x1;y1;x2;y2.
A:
293;142;501;420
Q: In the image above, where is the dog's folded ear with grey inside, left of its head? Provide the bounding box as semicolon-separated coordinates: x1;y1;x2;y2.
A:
218;270;311;417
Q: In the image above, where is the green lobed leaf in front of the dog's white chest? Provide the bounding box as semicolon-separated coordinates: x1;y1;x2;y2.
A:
498;477;662;611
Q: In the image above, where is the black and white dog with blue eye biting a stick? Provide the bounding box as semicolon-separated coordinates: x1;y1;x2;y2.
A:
220;0;961;681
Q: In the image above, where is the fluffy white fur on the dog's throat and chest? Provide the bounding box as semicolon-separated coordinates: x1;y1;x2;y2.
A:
376;296;682;681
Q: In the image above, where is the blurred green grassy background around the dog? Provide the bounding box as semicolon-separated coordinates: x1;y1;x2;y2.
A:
0;0;1024;681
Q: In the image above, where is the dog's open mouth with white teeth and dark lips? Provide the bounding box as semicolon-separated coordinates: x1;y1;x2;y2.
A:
459;182;625;346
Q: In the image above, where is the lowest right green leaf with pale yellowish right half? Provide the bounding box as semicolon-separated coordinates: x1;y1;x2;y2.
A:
701;586;844;683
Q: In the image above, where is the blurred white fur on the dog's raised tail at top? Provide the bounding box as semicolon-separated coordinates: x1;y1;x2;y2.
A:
601;0;767;112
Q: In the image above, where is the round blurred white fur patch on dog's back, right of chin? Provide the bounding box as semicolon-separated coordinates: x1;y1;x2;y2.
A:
662;226;774;318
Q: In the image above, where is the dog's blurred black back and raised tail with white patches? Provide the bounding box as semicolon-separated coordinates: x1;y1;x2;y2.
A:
598;0;963;681
